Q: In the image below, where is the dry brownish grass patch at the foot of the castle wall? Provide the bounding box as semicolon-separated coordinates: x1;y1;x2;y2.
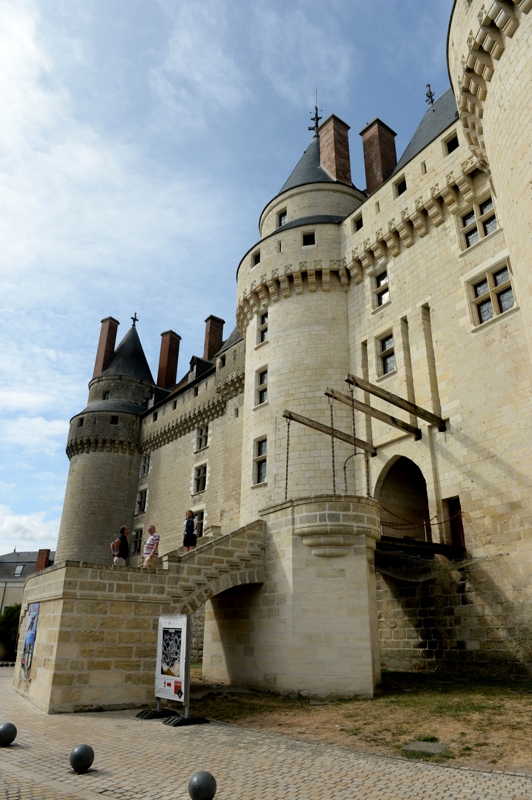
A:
191;672;532;769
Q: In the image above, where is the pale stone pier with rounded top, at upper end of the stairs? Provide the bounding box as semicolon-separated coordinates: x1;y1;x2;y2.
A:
203;495;380;697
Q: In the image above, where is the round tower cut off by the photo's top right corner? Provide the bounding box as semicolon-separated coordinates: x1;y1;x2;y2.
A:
447;0;532;354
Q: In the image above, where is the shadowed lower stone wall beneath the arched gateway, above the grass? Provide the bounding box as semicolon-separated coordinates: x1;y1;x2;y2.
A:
377;558;532;677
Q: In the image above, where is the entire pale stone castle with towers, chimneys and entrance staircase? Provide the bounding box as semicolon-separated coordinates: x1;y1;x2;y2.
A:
16;0;532;711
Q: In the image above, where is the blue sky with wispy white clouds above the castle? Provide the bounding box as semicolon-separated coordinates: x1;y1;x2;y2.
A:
0;0;452;553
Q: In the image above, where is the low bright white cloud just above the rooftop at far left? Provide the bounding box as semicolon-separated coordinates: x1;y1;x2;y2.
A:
0;505;59;554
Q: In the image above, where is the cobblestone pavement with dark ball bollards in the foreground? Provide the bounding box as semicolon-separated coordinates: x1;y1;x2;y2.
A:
0;669;532;800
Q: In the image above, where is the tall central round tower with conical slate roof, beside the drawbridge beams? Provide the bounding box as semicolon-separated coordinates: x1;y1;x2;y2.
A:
237;115;365;524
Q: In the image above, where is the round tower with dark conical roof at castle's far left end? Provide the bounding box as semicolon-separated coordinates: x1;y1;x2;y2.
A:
56;317;154;563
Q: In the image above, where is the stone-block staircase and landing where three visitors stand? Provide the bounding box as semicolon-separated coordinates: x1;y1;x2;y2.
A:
15;522;264;713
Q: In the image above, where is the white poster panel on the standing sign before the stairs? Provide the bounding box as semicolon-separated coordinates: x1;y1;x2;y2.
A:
155;614;188;703
